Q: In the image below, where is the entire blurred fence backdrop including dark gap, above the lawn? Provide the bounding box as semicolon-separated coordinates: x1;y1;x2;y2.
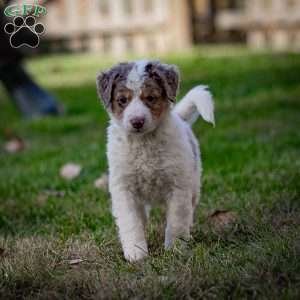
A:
20;0;300;56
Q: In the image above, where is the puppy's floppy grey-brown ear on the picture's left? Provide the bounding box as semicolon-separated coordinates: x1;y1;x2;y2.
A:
96;68;119;108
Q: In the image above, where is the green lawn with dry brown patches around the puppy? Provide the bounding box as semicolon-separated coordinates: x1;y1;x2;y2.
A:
0;48;300;299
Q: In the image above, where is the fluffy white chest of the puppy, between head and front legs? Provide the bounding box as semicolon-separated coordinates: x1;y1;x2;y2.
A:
107;113;195;202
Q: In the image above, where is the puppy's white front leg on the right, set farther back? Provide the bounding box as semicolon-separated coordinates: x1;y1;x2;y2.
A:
165;189;194;249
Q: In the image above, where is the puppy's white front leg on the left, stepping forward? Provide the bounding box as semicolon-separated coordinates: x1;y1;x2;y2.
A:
111;190;148;262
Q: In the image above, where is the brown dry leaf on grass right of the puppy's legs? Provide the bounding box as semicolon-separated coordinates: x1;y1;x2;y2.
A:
208;209;237;231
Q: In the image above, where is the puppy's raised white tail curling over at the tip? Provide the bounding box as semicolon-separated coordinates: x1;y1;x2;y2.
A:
174;85;215;126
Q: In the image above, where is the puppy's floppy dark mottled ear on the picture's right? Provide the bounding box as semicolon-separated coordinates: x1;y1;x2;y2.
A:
146;62;180;102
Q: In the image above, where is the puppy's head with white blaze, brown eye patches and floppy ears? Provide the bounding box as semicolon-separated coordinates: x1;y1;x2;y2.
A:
97;61;179;134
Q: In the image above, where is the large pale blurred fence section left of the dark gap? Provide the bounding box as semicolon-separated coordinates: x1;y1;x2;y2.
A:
43;0;191;56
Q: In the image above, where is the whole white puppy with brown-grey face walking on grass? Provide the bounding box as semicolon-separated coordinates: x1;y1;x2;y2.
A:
96;60;214;262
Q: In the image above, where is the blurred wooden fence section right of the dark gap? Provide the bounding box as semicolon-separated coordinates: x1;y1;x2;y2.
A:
217;0;300;50
